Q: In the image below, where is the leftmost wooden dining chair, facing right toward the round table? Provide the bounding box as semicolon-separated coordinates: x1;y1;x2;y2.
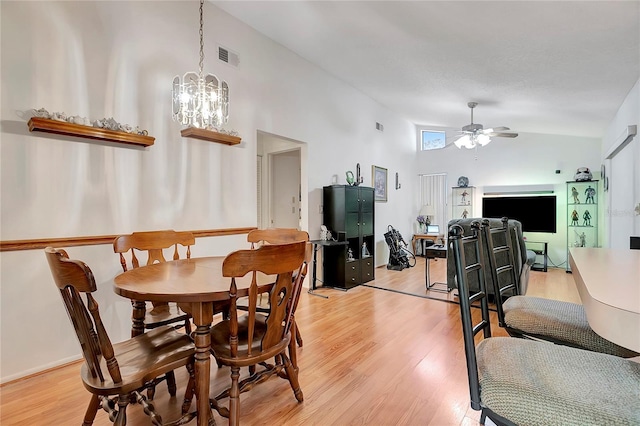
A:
45;247;196;426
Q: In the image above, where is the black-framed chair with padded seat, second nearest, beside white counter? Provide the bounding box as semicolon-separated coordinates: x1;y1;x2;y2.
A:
482;217;640;358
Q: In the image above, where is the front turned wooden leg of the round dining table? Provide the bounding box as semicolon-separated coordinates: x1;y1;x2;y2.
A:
191;303;215;426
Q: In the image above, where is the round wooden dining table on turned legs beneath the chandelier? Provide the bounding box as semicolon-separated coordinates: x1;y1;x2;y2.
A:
113;256;260;426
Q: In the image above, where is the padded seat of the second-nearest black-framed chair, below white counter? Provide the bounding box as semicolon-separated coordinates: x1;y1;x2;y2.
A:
503;296;640;358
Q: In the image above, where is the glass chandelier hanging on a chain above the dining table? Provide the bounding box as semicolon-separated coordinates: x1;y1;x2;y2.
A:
172;0;229;130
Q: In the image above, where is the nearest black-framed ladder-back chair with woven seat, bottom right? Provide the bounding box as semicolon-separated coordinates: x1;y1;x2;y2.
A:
449;225;640;426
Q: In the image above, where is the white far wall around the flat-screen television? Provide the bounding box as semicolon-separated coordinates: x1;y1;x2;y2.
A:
414;127;600;267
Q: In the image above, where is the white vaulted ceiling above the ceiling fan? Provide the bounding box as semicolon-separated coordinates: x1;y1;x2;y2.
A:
212;1;640;137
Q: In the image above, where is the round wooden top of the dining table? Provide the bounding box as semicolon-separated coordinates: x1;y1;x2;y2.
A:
113;256;261;303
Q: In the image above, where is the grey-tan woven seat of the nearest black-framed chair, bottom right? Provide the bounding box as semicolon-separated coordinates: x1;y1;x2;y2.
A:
476;337;640;426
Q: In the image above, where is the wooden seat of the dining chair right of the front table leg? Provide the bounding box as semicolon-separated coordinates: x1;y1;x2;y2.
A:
211;314;289;367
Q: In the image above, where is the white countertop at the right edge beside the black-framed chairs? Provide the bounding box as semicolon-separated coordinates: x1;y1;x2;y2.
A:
569;247;640;352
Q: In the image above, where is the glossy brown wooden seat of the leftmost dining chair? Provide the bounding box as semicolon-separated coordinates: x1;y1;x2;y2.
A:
81;326;195;395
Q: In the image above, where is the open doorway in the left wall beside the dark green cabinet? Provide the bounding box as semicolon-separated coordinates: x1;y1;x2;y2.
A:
257;131;308;230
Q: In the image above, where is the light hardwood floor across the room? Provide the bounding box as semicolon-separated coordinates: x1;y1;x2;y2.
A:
0;258;579;426
